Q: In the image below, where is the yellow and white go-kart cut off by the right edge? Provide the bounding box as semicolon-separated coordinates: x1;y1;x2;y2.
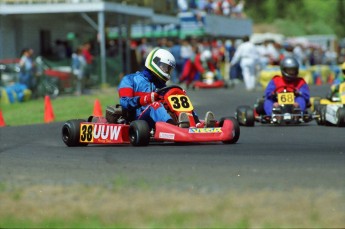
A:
310;83;345;127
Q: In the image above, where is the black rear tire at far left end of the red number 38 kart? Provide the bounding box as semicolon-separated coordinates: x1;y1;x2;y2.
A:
62;119;88;147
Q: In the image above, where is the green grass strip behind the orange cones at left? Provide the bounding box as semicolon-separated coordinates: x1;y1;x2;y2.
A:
0;88;118;126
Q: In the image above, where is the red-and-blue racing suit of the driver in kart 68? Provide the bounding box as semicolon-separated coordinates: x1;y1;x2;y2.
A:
264;76;310;116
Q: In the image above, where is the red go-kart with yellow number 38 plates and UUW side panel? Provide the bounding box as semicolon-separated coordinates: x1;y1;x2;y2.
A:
62;85;240;146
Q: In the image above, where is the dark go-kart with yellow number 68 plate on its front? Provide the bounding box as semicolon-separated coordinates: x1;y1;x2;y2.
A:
235;89;316;126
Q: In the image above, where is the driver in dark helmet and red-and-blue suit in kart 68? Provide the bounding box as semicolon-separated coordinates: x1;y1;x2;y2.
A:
264;57;310;116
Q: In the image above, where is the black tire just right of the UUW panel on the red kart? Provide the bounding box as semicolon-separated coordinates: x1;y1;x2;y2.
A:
129;120;150;146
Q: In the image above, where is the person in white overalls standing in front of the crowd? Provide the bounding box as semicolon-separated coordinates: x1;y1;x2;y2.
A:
230;36;259;91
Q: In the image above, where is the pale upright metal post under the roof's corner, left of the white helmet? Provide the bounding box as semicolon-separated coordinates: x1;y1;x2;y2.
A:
98;12;107;86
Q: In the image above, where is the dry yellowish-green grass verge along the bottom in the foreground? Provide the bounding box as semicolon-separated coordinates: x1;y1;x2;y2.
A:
0;186;345;228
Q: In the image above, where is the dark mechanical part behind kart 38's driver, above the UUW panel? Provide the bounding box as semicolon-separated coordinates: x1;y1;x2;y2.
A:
105;104;135;124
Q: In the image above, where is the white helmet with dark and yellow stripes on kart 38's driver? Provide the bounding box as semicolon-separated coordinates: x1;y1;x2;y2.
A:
145;48;176;82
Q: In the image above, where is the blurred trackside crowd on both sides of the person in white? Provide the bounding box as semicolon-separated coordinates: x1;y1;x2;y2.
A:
123;37;338;89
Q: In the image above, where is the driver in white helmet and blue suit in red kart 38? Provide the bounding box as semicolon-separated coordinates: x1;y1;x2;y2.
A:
118;48;215;128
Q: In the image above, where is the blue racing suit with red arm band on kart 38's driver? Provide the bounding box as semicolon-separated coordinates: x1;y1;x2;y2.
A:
118;68;176;128
